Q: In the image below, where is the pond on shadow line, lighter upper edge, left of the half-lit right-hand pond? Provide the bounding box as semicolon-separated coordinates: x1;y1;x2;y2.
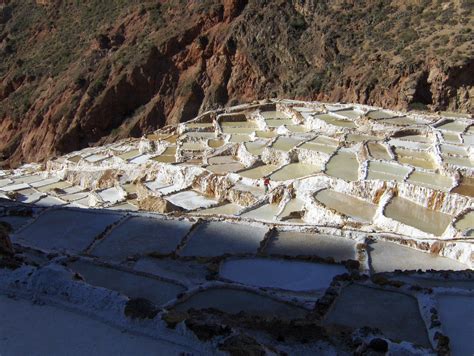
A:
264;231;356;262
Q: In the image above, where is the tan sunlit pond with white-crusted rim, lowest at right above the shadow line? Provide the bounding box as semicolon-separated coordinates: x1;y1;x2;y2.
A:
384;197;452;236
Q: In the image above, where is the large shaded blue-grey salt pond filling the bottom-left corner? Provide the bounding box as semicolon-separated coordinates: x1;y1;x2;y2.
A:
0;295;194;355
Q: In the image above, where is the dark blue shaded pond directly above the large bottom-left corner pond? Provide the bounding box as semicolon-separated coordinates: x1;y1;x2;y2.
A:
68;260;185;305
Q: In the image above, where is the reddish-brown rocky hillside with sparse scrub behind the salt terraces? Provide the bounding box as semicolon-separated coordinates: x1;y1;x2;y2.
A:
0;0;474;166
